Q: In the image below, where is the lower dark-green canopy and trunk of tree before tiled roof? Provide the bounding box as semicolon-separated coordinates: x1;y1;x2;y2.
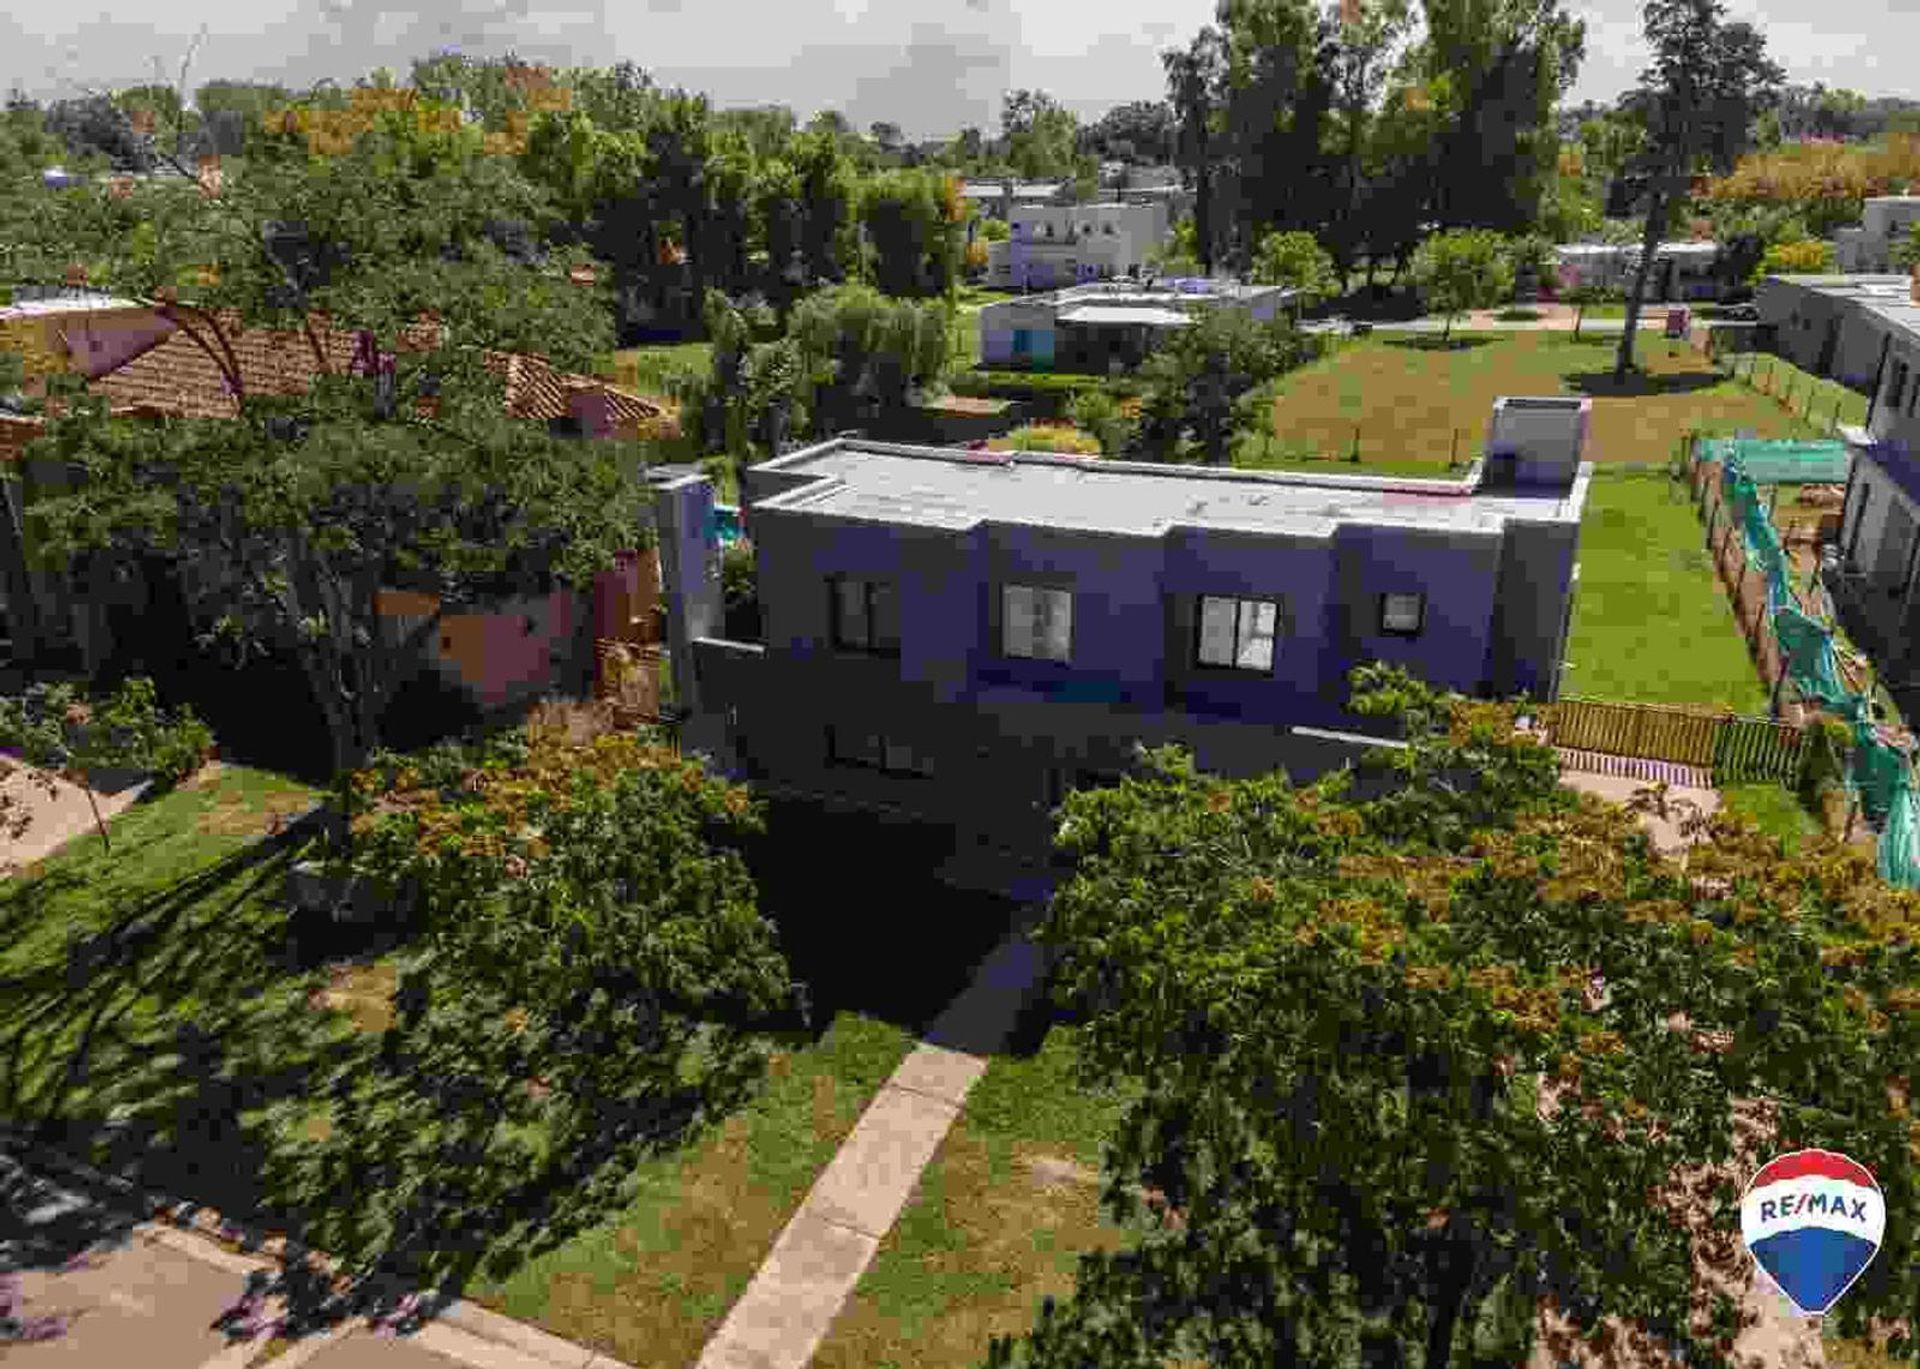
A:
18;374;643;770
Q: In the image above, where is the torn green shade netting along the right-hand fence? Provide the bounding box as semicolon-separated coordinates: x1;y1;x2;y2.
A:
1695;438;1920;889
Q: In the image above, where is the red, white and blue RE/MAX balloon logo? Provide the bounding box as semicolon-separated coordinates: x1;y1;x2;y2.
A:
1740;1150;1887;1317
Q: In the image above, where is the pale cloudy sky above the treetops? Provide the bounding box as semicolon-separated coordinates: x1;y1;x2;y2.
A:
0;0;1920;136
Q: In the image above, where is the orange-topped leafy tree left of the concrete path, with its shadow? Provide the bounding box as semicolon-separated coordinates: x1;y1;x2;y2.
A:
259;728;795;1286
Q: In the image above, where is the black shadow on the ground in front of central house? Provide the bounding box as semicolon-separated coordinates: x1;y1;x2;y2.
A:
745;799;1023;1039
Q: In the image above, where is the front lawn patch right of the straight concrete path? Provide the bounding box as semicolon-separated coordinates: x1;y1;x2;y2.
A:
814;1027;1127;1369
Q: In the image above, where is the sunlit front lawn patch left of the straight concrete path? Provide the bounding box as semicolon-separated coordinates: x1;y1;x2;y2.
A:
467;1014;912;1365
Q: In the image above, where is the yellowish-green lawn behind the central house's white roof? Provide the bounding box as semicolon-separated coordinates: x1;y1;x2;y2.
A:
1238;332;1814;474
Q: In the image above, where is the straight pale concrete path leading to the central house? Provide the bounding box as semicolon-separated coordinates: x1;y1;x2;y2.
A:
699;906;1044;1369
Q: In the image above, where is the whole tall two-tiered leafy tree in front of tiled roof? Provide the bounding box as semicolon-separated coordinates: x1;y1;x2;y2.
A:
0;90;641;779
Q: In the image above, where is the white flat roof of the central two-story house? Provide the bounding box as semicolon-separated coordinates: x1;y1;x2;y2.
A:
741;438;1592;540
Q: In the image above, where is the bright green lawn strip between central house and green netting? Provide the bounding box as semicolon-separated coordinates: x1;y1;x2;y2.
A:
1561;472;1766;714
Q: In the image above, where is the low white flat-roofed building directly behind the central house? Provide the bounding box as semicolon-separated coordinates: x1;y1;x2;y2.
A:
979;280;1296;374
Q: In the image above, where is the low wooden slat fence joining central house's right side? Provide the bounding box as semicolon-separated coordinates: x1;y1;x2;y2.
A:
1544;699;1803;783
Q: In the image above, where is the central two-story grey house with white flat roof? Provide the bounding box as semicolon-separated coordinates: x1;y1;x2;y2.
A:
655;397;1592;898
